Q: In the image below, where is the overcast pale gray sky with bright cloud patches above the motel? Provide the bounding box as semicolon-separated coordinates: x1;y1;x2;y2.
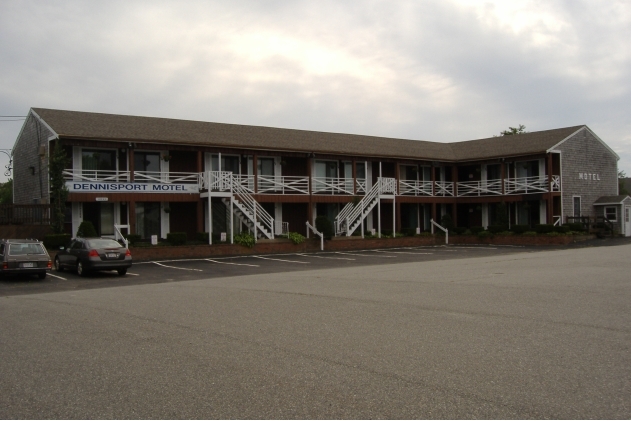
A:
0;0;631;180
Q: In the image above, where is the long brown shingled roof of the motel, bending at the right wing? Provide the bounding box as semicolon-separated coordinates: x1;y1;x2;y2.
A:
33;108;584;161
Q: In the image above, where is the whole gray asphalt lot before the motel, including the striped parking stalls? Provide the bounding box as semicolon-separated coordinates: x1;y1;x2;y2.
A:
0;242;631;419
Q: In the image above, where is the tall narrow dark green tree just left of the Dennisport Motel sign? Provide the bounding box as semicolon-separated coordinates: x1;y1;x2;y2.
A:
48;140;70;234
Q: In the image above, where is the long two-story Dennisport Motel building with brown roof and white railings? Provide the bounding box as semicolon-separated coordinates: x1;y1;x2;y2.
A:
13;108;631;242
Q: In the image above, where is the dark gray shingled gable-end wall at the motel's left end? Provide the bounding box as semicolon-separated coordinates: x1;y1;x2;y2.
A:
13;115;53;204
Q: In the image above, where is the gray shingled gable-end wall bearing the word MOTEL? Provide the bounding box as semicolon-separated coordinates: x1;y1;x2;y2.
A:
554;128;618;221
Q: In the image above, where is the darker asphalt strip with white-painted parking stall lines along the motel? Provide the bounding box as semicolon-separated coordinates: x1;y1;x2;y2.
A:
0;245;532;297
